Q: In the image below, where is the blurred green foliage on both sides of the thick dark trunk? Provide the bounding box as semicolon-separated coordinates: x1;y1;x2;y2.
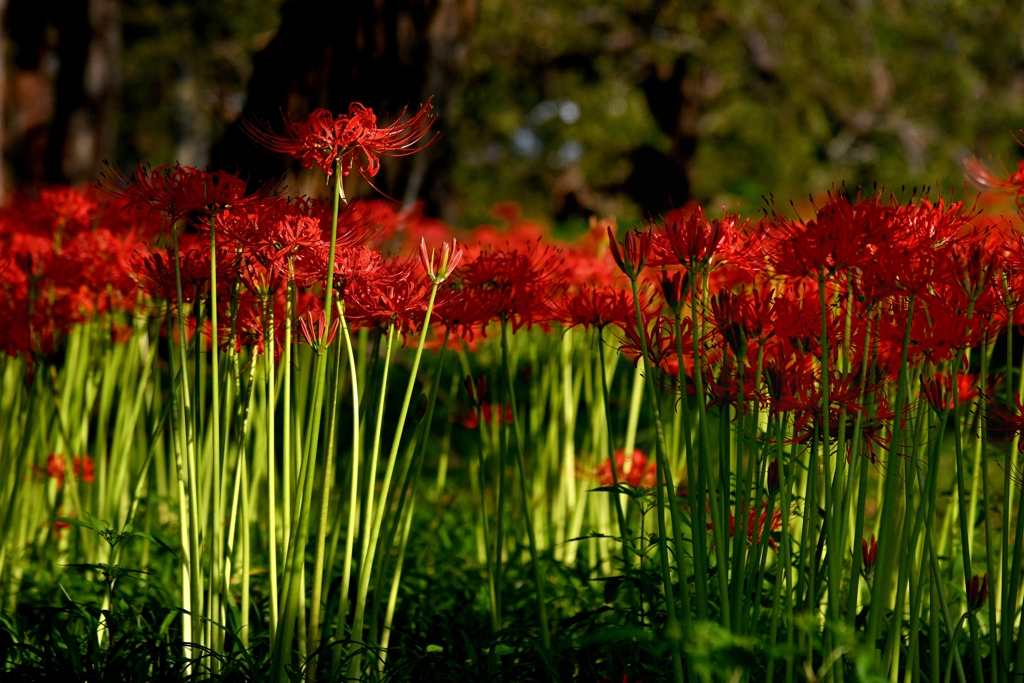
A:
110;0;1024;225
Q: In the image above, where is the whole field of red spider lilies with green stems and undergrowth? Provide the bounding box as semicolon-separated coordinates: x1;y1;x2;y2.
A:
0;103;1024;683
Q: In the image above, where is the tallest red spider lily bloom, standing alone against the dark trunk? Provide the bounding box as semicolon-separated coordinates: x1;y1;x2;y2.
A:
244;100;434;178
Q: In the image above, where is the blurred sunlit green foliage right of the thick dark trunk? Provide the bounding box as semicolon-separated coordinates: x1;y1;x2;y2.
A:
451;0;1024;222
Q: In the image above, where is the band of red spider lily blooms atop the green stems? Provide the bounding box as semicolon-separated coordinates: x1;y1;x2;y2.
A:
6;104;1024;479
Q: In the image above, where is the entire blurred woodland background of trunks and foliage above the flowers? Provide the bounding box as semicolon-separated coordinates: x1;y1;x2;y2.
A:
0;0;1024;226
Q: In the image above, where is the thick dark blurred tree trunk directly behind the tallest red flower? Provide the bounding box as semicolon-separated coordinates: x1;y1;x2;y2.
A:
213;0;477;213
